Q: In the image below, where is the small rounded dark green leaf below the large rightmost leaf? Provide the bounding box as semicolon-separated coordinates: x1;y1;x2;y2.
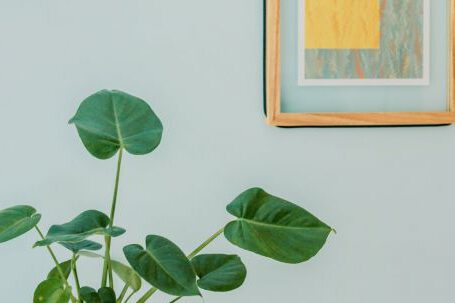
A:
191;254;246;292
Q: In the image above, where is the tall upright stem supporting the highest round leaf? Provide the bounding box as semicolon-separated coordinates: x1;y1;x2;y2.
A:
101;148;123;288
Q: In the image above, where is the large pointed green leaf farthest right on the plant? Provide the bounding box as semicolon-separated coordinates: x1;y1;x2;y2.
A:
224;188;332;264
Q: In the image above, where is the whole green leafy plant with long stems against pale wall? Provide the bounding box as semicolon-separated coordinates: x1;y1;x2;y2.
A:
0;90;332;303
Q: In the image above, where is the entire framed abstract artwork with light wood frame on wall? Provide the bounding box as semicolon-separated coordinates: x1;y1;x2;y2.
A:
264;0;455;126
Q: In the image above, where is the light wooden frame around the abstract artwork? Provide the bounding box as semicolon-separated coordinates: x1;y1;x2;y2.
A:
264;0;455;127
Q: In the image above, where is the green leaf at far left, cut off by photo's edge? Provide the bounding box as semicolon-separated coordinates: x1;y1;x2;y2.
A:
0;205;41;243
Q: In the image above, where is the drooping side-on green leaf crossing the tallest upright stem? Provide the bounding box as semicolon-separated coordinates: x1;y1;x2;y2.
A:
35;210;125;246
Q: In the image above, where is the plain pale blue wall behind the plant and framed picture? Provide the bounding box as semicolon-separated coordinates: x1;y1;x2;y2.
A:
0;0;455;303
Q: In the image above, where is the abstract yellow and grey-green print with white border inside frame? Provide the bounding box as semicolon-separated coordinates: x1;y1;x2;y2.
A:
298;0;430;86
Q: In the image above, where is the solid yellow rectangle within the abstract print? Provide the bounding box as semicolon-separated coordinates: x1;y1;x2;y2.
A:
305;0;381;49
